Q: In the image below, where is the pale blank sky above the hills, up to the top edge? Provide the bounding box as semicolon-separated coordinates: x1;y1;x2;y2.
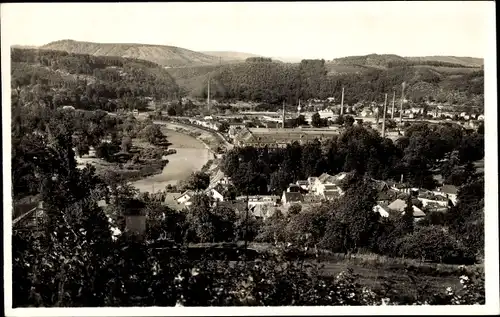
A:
1;1;495;60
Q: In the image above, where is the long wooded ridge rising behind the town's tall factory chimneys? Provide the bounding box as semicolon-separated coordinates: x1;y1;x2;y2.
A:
168;60;484;106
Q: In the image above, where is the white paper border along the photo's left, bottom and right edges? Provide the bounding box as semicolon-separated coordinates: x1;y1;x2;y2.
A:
1;2;500;316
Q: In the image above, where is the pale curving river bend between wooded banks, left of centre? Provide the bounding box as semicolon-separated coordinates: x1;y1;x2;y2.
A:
132;129;213;192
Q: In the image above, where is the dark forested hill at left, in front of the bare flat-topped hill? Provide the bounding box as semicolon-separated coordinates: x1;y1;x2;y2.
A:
11;48;179;111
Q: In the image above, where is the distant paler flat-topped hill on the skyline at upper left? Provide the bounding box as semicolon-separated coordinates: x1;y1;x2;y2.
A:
40;40;219;67
